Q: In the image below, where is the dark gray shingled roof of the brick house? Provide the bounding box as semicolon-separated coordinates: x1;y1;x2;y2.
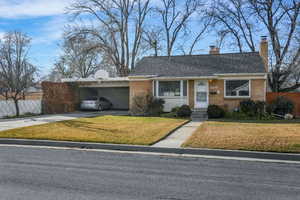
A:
130;52;266;77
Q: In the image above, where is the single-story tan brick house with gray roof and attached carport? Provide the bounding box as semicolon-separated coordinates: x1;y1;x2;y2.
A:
58;38;268;111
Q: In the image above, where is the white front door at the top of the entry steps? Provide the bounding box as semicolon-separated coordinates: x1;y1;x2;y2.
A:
195;80;208;108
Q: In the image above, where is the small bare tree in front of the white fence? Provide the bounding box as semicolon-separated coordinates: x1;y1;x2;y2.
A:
0;32;37;116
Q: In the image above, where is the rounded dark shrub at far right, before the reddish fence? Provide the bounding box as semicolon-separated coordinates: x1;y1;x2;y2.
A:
267;97;295;115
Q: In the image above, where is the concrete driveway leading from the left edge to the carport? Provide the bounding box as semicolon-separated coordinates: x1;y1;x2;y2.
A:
0;111;128;131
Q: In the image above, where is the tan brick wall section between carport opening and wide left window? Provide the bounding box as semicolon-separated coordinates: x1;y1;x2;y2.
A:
129;80;152;108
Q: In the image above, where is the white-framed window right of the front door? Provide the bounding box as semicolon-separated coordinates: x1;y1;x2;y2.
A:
225;80;250;97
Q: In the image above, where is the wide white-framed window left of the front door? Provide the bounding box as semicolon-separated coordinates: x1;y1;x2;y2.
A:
153;80;187;97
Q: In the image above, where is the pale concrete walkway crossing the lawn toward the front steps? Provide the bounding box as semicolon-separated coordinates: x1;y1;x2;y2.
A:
152;121;202;148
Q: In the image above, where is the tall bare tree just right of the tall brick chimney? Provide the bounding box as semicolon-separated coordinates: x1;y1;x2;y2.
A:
249;0;300;92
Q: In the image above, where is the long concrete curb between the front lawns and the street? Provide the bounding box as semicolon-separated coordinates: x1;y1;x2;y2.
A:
0;138;300;161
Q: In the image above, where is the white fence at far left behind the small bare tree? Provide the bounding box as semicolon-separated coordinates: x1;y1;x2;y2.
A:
0;100;42;118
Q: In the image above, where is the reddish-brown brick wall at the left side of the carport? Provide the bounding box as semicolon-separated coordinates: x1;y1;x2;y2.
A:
42;82;79;114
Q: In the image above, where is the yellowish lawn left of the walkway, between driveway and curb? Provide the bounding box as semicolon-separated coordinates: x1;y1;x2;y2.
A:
0;116;187;145
